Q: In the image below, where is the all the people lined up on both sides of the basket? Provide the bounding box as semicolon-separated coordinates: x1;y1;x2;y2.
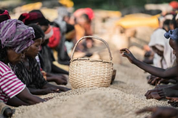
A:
0;1;178;118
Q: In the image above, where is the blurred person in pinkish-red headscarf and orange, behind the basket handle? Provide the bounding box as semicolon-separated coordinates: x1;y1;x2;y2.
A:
74;8;94;51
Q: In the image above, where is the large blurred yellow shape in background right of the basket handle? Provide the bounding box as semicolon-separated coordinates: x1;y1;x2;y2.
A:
116;14;160;28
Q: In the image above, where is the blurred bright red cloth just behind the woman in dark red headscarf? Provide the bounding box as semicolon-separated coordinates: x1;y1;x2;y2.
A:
48;27;61;48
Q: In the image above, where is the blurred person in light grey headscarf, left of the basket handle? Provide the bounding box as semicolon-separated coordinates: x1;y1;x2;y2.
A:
53;6;72;65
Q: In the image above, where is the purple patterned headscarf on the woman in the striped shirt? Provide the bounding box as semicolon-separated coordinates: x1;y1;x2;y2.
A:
0;19;35;53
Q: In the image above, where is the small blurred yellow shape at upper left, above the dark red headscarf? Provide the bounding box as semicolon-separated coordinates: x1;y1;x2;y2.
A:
21;2;42;11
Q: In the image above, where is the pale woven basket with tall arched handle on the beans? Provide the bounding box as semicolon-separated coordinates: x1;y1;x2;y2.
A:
69;36;113;89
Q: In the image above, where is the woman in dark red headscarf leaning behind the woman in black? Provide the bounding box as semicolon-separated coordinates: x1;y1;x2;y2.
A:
19;10;68;84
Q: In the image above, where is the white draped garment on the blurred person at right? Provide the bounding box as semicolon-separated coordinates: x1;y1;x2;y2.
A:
149;29;176;69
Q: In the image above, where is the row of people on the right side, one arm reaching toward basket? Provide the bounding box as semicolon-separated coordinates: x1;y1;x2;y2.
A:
120;3;178;118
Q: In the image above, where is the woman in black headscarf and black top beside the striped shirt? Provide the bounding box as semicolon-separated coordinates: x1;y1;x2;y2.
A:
13;24;69;95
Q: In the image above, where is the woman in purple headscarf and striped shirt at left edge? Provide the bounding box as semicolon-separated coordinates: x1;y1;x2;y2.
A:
0;19;44;106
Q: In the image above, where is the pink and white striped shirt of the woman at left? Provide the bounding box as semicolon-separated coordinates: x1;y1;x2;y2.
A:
0;61;26;103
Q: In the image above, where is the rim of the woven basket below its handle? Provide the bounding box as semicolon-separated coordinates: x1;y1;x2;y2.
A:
70;58;113;65
